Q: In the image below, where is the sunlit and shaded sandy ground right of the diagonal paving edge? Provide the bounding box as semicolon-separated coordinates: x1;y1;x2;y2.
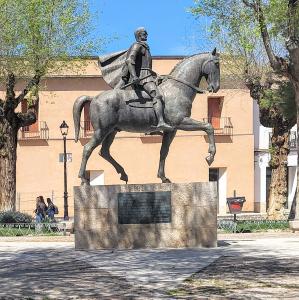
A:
170;235;299;300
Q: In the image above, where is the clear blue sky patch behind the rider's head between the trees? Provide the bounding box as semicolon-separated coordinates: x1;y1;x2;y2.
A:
89;0;212;55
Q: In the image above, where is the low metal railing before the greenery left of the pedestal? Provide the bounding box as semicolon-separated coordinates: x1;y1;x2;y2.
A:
0;223;66;237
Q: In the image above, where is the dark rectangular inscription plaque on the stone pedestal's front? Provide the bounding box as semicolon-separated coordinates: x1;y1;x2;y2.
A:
118;192;171;224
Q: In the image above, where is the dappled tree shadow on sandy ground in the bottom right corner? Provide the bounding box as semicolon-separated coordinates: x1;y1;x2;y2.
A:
169;255;299;299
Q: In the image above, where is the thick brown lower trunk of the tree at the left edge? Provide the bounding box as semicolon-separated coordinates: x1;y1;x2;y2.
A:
0;117;18;211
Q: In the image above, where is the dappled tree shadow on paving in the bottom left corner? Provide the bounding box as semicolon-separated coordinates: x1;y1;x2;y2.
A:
0;250;165;300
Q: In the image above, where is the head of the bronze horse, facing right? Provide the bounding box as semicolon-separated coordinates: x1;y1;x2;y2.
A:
201;48;220;93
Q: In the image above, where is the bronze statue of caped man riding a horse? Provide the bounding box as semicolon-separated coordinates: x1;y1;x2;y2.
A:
73;27;220;184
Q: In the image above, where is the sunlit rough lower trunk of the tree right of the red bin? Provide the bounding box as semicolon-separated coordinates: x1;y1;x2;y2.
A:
267;128;289;220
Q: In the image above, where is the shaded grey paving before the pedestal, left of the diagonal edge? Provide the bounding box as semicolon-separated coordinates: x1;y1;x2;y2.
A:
0;246;219;300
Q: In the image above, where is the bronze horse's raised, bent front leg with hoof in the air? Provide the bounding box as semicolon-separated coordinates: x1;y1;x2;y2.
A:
176;117;216;166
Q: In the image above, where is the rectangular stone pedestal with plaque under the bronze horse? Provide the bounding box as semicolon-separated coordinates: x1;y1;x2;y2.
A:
74;182;218;250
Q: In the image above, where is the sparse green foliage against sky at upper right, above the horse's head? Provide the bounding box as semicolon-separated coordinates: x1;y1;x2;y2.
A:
190;0;299;78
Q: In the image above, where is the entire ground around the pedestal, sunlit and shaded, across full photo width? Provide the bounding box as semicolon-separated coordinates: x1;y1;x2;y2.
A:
0;233;299;299
